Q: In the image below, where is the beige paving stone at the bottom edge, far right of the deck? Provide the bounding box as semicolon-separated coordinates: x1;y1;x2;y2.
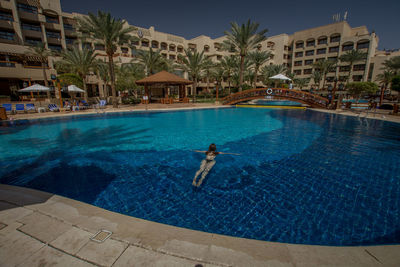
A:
287;245;380;267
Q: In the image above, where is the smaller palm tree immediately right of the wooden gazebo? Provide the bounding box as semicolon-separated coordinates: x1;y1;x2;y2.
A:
178;49;207;103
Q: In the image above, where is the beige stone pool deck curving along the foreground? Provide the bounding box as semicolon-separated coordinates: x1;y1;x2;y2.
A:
0;184;400;266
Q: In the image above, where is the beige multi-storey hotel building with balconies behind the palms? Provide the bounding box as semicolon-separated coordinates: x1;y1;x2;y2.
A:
0;0;399;97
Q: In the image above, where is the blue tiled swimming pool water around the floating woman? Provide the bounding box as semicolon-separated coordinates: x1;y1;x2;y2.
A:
0;108;400;245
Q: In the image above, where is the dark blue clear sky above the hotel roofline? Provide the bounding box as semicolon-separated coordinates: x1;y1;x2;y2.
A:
61;0;400;49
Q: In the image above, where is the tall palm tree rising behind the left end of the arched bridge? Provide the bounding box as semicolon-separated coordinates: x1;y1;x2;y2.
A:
224;20;268;91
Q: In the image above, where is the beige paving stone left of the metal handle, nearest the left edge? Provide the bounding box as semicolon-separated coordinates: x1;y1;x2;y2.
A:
19;212;72;243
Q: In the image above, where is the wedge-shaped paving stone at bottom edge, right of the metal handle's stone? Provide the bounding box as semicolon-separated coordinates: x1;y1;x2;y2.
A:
113;246;213;267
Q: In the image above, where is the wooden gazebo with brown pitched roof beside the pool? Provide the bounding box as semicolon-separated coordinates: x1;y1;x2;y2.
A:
136;71;193;104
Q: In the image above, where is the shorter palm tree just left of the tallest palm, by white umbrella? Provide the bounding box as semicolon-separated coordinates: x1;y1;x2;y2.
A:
57;47;98;101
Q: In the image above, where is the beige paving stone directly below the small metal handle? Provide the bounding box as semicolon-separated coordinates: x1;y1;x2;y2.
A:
76;239;128;266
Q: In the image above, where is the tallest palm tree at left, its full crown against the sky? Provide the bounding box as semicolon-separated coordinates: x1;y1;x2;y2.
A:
78;11;136;108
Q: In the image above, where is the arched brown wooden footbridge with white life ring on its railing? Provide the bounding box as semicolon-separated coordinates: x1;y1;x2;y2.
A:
221;88;329;108
